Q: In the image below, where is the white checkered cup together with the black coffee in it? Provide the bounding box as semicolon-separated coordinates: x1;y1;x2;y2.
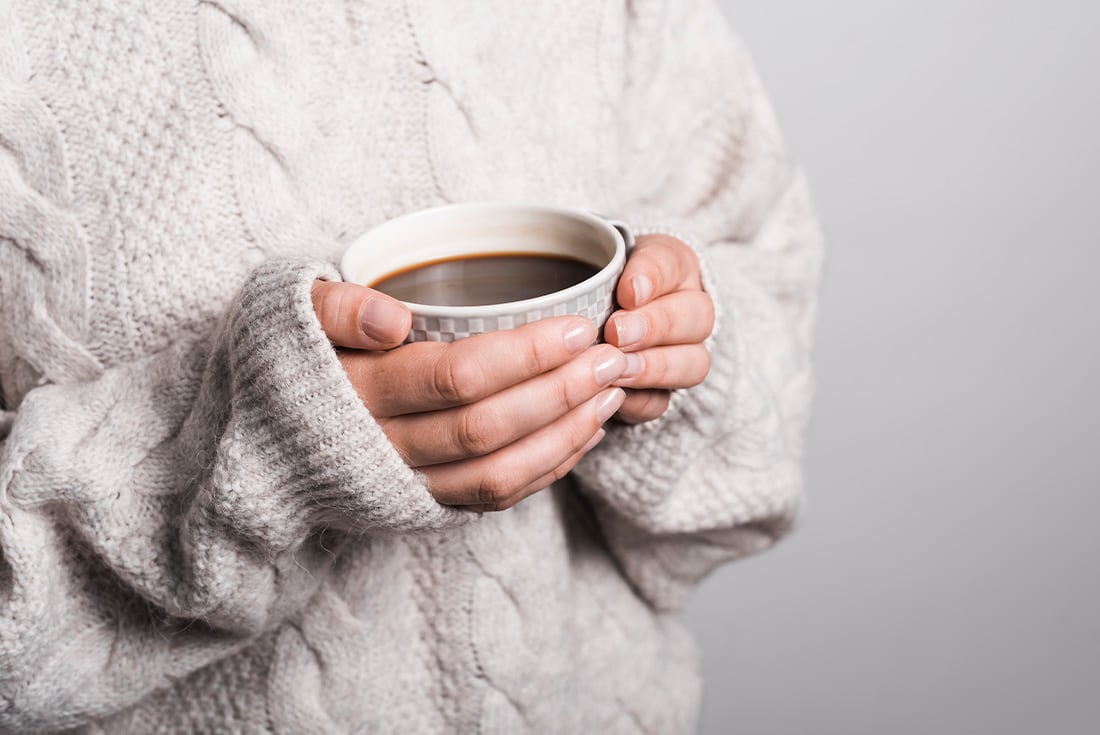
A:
340;202;634;342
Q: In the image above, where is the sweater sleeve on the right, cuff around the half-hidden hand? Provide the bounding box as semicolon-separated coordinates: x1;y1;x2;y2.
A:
574;0;823;610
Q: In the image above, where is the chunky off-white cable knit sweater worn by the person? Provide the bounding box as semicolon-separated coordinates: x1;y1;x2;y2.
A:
0;0;821;735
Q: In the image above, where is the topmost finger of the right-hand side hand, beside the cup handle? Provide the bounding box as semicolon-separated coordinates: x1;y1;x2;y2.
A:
615;234;703;309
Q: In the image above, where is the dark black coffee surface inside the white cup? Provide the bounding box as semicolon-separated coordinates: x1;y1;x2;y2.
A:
371;253;600;306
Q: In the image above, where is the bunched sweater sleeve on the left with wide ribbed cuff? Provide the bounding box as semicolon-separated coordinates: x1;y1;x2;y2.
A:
0;260;470;732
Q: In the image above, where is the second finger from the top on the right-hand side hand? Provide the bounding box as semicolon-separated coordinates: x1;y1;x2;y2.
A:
604;290;714;352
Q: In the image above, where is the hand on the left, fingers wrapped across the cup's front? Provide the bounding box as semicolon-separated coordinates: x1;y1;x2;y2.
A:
312;281;627;512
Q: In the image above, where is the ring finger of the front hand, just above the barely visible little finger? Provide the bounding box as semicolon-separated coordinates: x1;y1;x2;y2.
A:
420;388;626;508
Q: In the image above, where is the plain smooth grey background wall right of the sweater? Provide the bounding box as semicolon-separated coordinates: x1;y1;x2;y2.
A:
689;0;1100;735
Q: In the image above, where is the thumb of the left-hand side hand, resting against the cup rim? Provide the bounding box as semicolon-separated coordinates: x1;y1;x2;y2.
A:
311;281;413;350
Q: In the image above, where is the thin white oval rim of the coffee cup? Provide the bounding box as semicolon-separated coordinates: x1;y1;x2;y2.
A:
340;201;627;319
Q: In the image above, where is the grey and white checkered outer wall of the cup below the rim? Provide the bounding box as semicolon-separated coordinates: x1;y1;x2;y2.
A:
406;265;619;342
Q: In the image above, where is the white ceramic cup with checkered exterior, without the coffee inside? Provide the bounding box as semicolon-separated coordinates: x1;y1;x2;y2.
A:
340;202;634;342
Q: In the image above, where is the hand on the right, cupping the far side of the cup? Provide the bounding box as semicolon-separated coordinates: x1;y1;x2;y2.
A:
604;234;714;424
